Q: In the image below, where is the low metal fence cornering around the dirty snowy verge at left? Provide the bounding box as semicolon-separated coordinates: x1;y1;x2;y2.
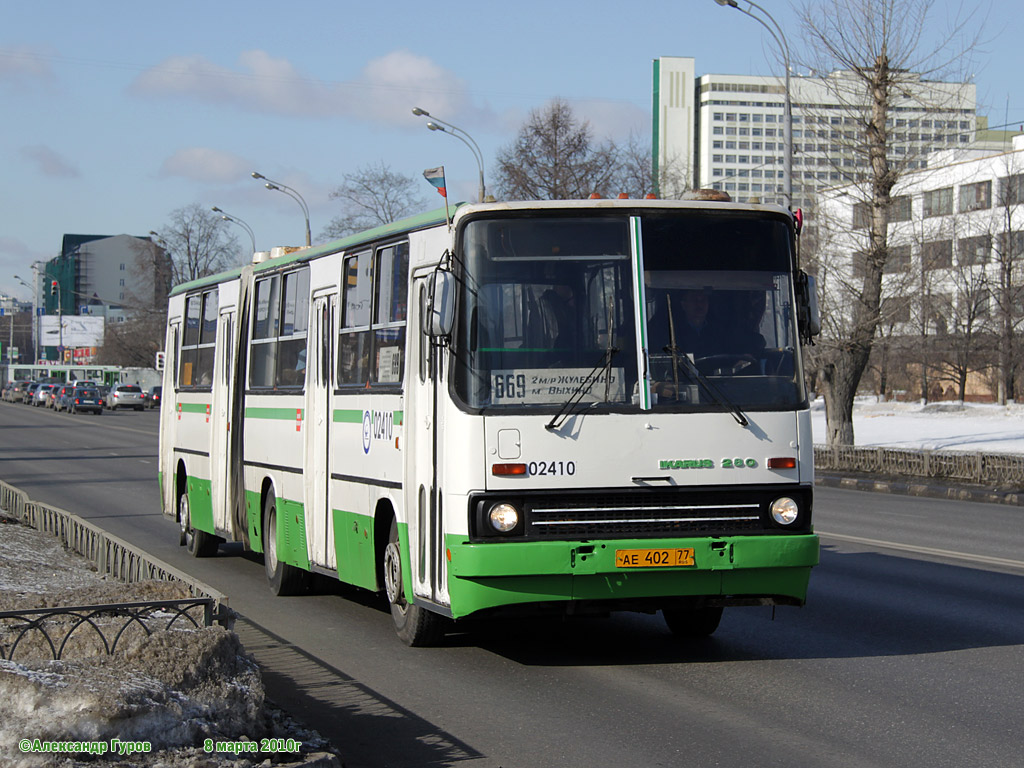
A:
0;480;234;658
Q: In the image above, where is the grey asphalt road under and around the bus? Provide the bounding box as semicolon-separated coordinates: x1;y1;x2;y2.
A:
0;403;1024;768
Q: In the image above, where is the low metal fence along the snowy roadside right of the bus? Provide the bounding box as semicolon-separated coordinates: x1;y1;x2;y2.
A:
814;445;1024;488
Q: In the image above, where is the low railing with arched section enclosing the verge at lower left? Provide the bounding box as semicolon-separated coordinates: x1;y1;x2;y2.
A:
0;480;234;659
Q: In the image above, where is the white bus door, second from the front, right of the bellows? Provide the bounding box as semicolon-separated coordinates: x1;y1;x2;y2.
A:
302;294;337;568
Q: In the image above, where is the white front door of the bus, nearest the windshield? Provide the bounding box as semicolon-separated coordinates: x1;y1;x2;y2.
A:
399;272;447;604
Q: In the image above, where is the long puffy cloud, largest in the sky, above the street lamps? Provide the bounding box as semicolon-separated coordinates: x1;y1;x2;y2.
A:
129;50;466;124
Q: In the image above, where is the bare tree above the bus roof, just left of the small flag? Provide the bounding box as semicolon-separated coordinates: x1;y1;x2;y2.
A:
321;161;429;240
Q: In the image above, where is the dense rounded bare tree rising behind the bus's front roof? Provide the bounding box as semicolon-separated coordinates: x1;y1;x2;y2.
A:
495;99;620;200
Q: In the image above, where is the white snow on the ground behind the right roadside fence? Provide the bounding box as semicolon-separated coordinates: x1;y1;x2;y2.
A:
811;397;1024;454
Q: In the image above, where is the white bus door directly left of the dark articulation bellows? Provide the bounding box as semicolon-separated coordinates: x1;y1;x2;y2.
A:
209;307;239;539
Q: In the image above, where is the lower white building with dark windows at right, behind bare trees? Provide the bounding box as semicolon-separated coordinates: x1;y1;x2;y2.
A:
818;136;1024;346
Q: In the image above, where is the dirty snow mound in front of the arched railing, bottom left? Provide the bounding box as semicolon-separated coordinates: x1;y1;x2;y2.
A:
0;627;267;766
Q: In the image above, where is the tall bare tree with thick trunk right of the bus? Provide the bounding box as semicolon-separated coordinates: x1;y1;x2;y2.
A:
801;0;973;445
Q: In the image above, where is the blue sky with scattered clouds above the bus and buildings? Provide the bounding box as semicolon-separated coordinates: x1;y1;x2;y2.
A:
0;0;1024;300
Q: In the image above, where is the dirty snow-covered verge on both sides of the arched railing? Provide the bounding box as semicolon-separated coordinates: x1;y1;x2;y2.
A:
0;516;340;768
